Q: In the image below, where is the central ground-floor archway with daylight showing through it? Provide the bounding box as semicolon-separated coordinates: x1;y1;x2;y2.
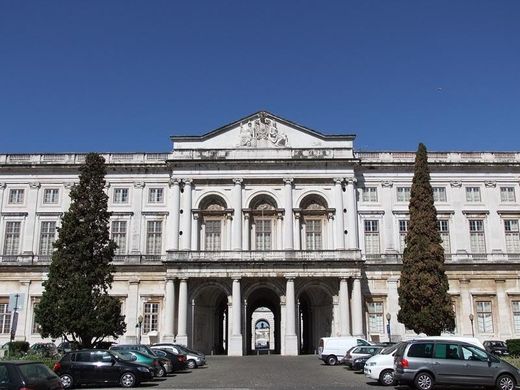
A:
245;286;281;354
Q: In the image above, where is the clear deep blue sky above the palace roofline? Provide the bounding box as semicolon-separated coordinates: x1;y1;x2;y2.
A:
0;0;520;153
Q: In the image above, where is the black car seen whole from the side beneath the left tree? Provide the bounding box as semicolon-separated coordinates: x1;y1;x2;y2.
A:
54;349;153;389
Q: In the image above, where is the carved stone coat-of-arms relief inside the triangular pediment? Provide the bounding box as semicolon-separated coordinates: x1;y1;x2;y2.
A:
239;112;289;148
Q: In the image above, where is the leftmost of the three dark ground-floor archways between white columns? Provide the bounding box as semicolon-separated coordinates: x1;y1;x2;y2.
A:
192;285;229;355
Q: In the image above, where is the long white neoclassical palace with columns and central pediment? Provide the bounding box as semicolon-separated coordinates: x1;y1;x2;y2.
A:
0;112;520;355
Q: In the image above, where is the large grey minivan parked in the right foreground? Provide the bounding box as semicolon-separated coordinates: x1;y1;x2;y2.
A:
394;339;520;390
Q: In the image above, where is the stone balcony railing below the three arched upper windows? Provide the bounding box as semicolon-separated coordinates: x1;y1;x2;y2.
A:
166;249;362;263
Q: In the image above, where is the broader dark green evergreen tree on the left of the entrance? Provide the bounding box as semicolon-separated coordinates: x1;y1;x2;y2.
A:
35;153;126;348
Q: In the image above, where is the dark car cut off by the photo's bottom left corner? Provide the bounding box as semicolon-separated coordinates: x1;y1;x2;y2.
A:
0;360;63;390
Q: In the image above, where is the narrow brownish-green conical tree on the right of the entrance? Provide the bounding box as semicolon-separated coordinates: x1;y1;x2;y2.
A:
397;143;455;336
